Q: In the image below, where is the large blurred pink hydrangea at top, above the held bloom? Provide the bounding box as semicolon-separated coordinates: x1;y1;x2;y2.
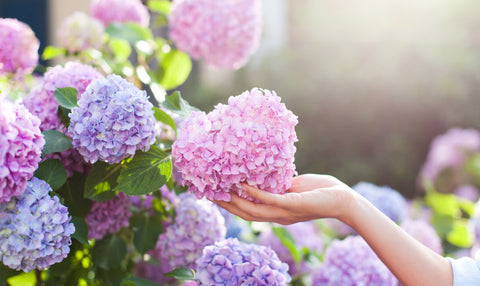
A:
169;0;262;70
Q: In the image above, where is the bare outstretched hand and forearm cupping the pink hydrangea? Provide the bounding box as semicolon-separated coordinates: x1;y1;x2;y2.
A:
215;174;453;286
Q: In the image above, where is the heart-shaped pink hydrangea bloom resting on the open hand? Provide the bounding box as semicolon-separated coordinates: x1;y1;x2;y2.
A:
172;89;298;201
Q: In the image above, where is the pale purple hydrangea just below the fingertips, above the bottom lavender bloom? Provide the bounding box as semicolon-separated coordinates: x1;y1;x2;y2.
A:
154;193;226;270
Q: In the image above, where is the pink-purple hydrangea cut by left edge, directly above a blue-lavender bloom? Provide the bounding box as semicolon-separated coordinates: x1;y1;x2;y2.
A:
0;98;45;204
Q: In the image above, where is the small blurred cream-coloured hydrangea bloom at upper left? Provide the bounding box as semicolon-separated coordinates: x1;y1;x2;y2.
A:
58;11;105;53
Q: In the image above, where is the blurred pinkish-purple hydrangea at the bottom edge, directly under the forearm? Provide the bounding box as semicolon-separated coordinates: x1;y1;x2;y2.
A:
312;236;398;286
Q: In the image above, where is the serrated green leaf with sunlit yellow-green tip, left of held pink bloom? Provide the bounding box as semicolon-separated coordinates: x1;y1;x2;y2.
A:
115;145;172;195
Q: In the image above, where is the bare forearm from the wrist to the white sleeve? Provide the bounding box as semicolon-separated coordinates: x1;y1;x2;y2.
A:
342;194;453;286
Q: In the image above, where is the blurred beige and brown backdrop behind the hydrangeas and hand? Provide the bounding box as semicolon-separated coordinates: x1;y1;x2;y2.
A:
0;0;480;197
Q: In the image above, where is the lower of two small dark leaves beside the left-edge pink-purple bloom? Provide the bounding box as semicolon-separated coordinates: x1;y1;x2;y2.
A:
34;159;67;191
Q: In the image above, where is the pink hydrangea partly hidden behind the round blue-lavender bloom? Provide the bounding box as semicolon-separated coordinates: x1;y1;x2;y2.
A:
23;62;102;131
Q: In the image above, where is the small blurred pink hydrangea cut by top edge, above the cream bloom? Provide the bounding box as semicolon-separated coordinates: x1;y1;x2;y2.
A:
90;0;150;28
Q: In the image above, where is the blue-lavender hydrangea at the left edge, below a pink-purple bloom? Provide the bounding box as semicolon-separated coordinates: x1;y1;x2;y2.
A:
0;177;75;272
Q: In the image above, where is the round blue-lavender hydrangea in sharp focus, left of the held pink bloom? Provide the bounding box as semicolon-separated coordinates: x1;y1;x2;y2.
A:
68;75;155;164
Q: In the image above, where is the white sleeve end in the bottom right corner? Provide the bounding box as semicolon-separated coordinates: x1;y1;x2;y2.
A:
447;251;480;286
